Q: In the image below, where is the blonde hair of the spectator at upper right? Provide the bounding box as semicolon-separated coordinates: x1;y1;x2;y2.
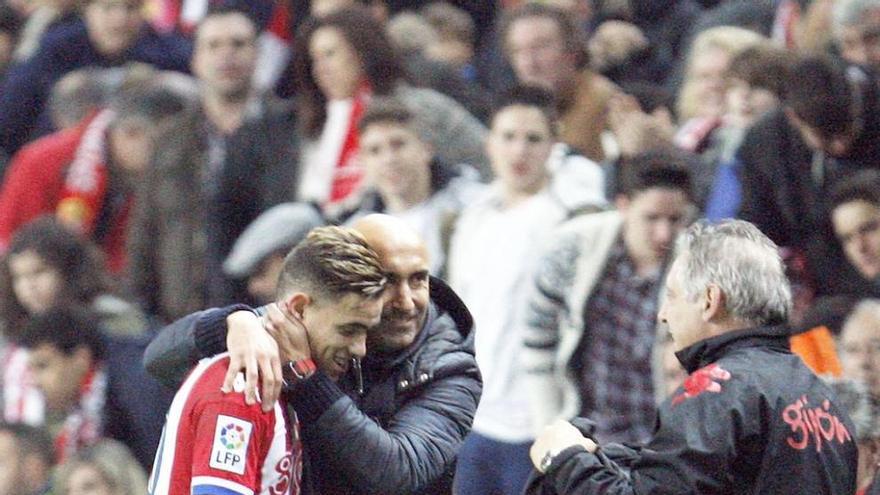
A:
676;26;767;122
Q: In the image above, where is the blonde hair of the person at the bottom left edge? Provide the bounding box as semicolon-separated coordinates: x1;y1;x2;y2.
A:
52;439;147;495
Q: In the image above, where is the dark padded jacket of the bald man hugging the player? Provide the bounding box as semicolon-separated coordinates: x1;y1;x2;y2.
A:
144;278;482;494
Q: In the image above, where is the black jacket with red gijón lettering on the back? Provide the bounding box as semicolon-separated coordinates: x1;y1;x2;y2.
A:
530;327;857;495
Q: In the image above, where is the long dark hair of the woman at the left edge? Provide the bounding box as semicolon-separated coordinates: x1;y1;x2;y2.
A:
0;216;110;337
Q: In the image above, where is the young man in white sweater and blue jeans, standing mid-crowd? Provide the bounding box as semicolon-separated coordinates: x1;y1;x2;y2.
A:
449;87;588;494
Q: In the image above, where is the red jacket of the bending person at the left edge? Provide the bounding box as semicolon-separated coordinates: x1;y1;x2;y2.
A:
0;113;128;272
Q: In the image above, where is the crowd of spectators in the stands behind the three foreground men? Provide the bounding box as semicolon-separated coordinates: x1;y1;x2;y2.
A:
0;0;880;495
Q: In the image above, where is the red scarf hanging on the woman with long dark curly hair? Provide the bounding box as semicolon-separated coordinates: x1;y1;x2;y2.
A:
327;83;372;205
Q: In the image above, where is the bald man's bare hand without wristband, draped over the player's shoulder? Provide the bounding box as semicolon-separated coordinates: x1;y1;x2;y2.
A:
221;311;281;412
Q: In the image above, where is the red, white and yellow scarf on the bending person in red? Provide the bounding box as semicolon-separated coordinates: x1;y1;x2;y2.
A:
55;110;131;273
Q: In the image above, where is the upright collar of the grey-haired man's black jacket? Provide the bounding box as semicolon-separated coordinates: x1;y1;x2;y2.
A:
675;325;791;374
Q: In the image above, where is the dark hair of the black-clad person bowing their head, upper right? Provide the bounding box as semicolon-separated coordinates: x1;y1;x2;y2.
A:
783;55;864;137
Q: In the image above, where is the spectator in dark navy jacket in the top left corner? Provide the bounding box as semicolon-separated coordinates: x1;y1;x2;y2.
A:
0;0;189;155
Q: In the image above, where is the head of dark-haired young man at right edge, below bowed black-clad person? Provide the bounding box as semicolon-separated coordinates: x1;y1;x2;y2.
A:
829;170;880;297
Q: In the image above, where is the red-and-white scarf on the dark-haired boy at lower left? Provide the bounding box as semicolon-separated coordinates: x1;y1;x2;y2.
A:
55;365;107;463
